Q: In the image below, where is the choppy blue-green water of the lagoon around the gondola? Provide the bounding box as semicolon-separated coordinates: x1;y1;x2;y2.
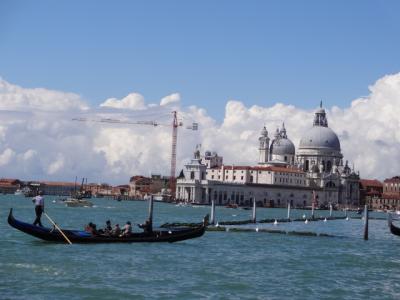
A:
0;196;400;300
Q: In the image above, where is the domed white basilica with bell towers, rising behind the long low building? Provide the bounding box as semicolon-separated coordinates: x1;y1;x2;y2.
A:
259;102;360;203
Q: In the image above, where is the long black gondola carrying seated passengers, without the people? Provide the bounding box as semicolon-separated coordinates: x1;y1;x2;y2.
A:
8;208;208;244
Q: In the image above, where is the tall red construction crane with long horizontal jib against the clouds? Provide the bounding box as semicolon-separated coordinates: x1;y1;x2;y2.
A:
72;111;198;199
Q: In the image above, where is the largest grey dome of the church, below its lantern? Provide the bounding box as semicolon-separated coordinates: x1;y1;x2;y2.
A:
299;126;340;152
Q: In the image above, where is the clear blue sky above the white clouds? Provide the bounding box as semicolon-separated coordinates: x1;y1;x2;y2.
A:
0;1;400;121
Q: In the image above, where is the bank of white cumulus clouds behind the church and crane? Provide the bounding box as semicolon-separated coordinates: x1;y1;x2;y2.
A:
0;73;400;183
